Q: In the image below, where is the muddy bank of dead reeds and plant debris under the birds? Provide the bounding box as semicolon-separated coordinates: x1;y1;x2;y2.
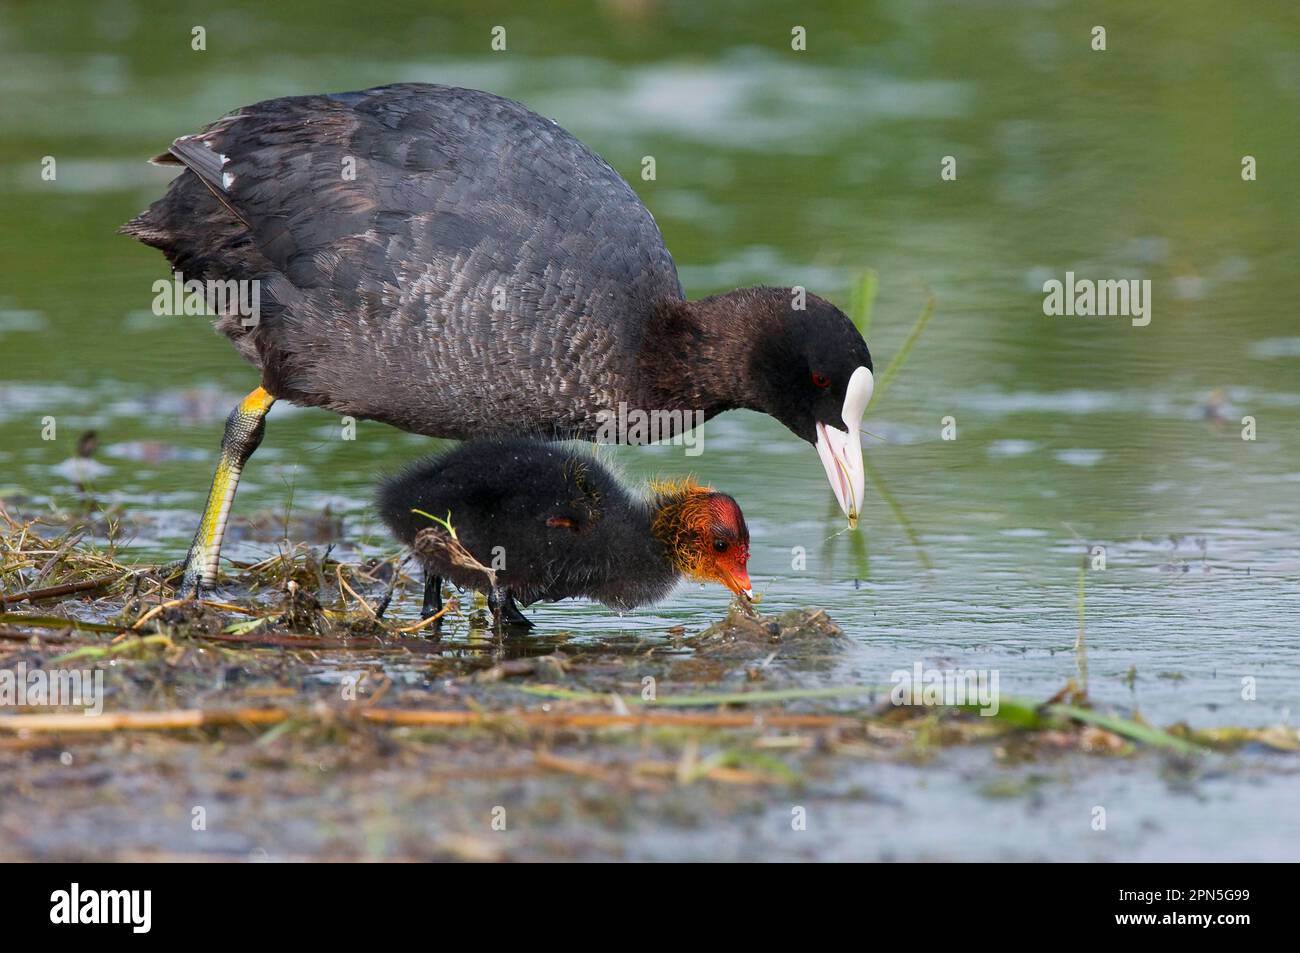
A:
0;512;1300;859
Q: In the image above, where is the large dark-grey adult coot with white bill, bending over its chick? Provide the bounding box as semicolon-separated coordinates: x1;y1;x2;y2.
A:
122;83;872;594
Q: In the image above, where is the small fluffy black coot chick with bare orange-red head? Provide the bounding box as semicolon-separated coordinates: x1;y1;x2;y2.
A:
378;438;753;627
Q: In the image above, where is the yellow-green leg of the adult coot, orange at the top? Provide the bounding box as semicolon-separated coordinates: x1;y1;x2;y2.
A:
177;387;276;597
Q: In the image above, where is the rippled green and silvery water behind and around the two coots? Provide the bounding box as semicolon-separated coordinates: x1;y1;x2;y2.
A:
0;0;1300;852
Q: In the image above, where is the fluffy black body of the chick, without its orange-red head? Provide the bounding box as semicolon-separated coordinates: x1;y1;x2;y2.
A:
378;439;679;621
